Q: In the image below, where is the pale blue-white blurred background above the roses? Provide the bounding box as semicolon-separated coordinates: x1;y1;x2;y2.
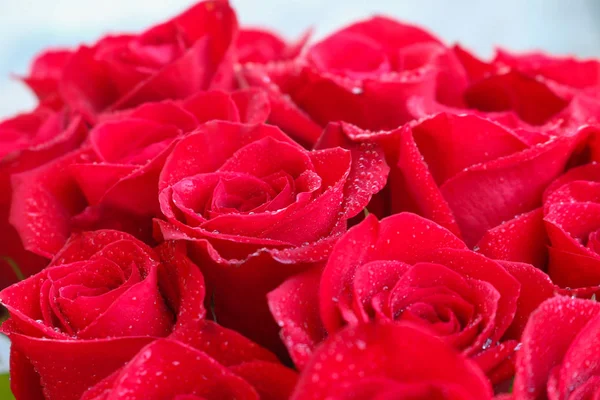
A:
0;0;600;118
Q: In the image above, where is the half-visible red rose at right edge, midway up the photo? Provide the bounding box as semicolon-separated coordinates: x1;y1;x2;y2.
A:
479;163;600;294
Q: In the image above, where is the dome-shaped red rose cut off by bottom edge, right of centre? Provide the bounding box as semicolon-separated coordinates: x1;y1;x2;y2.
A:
291;323;492;400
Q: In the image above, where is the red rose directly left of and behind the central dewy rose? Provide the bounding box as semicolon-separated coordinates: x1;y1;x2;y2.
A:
11;90;269;258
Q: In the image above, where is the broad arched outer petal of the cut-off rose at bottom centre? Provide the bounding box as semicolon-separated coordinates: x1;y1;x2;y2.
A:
292;324;492;400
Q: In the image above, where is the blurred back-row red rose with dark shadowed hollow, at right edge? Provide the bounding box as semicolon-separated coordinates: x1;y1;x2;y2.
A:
408;46;600;129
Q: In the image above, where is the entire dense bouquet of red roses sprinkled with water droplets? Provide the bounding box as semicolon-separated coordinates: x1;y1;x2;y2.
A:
0;0;600;400
